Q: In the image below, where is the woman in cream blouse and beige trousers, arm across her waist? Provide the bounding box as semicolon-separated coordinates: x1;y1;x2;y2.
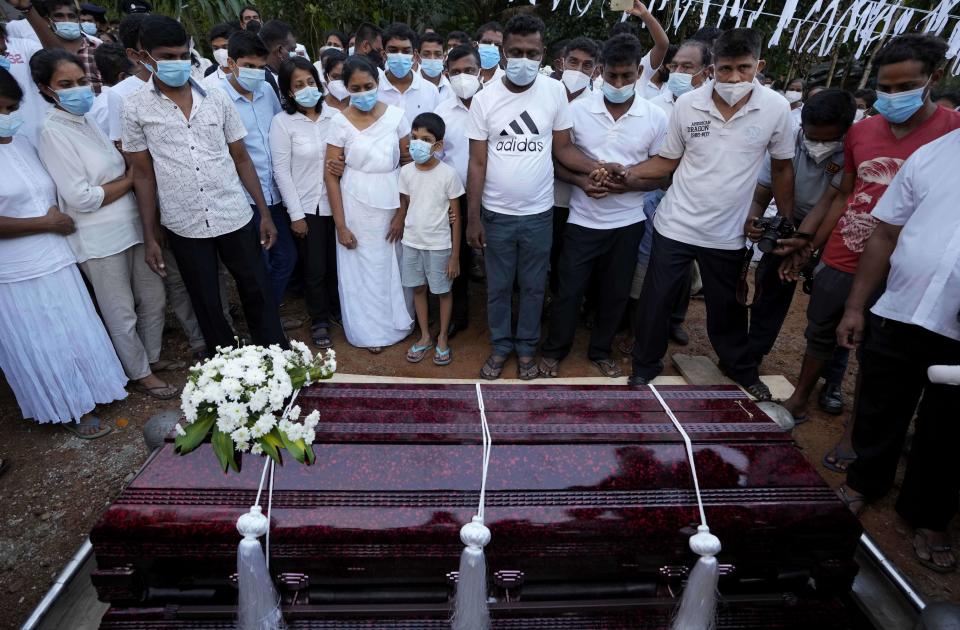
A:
30;49;179;400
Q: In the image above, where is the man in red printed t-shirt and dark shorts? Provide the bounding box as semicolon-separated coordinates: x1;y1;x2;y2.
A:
783;34;960;454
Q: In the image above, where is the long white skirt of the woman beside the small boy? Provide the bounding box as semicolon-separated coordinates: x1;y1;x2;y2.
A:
337;194;413;348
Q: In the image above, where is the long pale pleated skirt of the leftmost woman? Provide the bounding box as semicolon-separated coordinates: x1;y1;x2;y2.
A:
0;265;127;423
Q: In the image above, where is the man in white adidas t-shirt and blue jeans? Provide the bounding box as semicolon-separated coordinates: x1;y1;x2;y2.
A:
467;15;622;380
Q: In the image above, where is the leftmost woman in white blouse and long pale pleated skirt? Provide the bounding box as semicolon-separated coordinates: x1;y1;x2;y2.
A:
0;68;127;438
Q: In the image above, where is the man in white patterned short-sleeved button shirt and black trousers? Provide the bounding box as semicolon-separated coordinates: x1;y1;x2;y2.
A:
122;16;287;351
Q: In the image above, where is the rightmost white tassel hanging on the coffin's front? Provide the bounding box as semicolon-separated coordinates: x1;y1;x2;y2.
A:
673;525;720;630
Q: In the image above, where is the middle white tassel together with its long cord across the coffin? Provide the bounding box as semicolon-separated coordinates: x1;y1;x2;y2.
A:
451;383;493;630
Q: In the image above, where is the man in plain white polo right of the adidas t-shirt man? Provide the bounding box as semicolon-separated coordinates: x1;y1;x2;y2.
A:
540;35;667;378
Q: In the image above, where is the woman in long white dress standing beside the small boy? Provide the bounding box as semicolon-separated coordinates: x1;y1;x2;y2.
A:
325;57;413;354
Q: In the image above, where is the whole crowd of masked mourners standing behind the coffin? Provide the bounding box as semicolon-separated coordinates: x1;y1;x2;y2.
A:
0;0;960;572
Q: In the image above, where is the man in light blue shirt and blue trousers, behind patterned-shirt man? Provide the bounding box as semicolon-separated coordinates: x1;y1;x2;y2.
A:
221;31;297;316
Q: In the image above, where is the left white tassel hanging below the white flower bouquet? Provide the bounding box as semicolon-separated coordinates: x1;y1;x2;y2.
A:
237;460;286;630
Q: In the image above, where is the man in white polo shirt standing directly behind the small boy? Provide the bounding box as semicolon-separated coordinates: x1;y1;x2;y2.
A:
378;24;440;124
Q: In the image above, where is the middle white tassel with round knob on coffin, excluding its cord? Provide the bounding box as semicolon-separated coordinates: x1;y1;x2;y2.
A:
453;516;490;630
